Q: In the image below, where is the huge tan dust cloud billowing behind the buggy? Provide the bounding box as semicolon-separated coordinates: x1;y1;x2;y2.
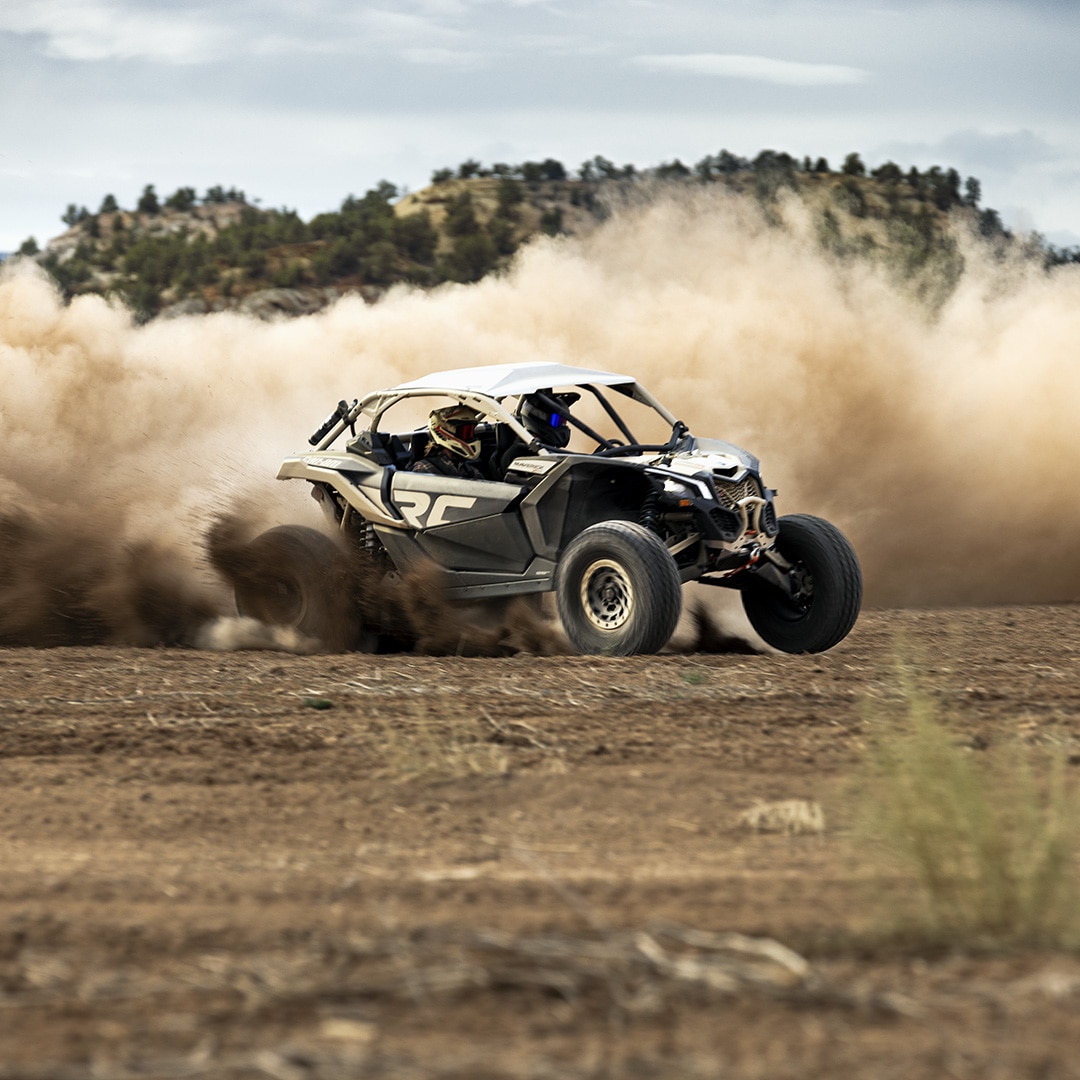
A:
0;183;1080;644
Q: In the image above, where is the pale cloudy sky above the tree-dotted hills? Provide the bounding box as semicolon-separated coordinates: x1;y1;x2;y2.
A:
0;0;1080;252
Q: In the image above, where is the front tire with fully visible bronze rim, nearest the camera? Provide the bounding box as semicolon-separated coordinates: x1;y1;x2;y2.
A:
555;522;683;657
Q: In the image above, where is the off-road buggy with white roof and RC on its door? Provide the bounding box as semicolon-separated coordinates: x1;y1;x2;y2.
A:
237;364;862;656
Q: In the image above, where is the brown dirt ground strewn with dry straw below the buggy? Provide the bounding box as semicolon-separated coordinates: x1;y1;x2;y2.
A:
0;606;1080;1080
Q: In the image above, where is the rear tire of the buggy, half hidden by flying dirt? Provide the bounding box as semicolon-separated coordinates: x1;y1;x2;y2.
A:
233;525;361;652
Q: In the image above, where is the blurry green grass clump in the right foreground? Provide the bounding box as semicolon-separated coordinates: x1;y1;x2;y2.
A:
866;678;1080;945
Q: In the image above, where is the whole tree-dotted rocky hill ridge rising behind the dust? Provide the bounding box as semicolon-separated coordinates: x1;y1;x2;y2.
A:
10;150;1080;319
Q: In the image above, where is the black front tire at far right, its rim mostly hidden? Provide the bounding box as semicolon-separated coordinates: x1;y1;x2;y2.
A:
742;514;863;652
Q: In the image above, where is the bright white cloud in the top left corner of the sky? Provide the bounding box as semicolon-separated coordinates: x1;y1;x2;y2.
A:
0;0;222;64
